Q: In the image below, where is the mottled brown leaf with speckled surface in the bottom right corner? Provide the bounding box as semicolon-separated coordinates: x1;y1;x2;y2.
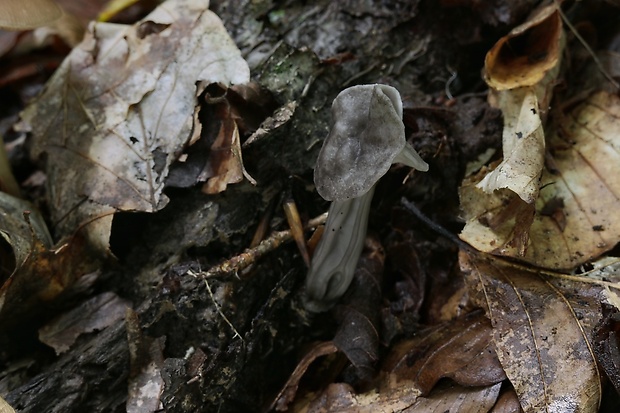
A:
460;253;601;413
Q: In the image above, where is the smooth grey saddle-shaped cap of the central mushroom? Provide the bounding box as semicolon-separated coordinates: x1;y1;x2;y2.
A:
314;84;405;201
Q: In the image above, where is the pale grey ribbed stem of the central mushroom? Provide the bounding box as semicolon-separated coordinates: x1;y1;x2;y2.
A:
305;185;376;312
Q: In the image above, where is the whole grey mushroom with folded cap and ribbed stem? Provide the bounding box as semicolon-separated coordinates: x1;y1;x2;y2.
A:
305;84;428;312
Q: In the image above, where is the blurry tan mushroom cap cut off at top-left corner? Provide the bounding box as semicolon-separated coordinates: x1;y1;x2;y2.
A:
0;0;62;30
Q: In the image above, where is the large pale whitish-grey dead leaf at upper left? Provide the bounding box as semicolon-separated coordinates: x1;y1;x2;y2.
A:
22;0;249;248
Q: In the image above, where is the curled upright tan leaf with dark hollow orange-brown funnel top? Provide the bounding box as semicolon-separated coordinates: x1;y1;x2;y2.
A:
462;4;564;257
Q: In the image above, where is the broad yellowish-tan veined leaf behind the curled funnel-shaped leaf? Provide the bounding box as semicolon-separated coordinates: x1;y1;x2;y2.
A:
461;92;620;269
